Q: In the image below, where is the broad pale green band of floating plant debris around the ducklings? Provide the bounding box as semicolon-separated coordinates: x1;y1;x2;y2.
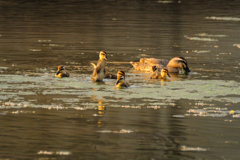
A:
0;75;240;110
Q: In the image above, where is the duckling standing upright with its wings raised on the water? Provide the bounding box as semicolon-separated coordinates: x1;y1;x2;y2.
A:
91;51;108;82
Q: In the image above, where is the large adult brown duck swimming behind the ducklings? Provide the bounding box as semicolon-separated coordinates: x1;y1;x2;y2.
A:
130;57;191;74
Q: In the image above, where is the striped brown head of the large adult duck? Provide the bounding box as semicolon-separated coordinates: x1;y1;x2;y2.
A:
168;57;191;74
